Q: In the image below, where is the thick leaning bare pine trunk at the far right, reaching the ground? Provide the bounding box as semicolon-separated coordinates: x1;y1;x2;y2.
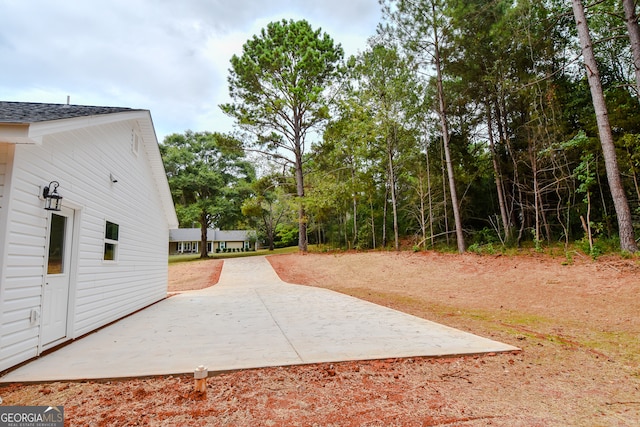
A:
572;0;638;252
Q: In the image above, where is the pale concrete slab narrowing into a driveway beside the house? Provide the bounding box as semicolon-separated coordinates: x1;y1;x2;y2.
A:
0;257;518;383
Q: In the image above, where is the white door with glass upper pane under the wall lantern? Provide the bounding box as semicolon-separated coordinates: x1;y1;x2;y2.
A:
41;207;73;348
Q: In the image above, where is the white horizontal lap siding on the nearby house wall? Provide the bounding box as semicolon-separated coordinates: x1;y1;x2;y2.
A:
0;117;168;371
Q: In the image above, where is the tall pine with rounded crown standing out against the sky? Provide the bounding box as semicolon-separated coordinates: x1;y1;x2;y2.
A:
221;20;344;251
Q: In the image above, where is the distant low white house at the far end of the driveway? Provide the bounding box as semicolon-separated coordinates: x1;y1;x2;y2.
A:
169;228;256;255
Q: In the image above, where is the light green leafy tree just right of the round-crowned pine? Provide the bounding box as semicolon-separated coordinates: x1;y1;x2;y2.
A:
307;42;422;249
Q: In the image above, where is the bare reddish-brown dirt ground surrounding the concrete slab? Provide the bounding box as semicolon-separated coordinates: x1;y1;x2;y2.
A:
0;252;640;426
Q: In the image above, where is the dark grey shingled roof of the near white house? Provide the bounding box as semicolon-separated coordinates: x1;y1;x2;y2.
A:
0;101;140;124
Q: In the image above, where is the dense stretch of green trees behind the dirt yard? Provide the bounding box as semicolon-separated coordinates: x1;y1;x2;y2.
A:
161;0;640;254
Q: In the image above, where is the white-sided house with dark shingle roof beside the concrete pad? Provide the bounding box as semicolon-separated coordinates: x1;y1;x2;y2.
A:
0;102;178;371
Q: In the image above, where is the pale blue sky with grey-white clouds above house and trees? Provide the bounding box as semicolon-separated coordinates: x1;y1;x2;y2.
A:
0;0;380;142
